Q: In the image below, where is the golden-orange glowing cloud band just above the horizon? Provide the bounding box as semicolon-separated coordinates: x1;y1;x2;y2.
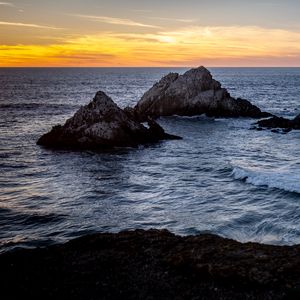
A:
0;25;300;67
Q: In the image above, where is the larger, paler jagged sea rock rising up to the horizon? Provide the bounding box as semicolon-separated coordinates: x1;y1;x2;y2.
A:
133;67;271;120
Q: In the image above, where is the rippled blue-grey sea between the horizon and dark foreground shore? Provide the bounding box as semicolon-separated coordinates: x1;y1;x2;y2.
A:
0;68;300;252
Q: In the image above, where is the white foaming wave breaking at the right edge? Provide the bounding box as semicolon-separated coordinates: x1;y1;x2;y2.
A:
231;167;300;194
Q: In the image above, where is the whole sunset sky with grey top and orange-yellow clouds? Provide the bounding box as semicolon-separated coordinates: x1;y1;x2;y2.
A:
0;0;300;67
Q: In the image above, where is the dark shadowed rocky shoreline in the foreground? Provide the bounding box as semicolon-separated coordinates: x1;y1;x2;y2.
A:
0;230;300;299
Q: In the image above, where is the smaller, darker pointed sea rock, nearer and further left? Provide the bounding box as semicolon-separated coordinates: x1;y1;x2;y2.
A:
37;91;178;149
